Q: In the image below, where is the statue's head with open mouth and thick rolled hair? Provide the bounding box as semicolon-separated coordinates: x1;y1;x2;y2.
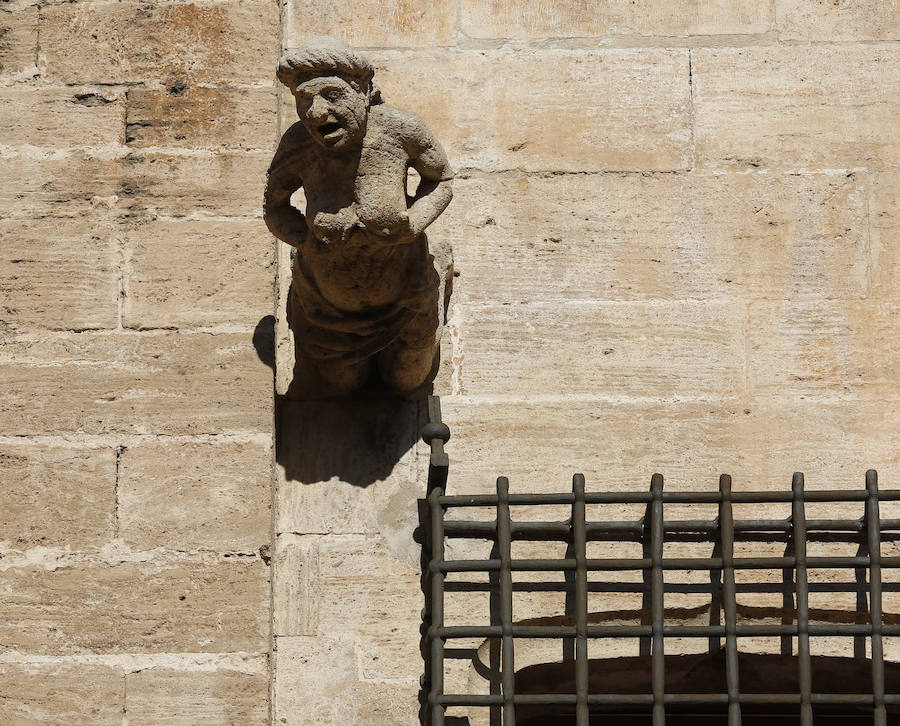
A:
278;38;381;151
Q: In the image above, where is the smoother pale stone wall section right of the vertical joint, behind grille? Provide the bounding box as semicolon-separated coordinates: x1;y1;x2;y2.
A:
275;0;900;726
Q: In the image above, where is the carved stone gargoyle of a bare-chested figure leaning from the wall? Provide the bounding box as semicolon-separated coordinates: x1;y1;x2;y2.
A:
264;38;453;395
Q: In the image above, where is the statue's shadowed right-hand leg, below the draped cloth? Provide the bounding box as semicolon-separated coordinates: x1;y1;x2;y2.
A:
377;307;441;391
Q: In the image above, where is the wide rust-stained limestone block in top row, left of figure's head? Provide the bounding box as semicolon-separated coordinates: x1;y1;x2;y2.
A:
41;0;280;84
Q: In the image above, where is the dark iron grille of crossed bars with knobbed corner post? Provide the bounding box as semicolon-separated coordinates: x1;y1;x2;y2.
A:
420;397;900;726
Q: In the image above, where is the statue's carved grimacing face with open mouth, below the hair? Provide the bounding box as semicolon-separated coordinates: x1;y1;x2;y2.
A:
294;76;369;151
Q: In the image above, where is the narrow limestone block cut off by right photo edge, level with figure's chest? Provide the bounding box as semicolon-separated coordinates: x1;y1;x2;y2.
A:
869;173;900;300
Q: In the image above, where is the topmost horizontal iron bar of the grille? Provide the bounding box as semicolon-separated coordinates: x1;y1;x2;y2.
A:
441;489;900;507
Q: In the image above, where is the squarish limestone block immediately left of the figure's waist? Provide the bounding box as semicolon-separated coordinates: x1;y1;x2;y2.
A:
122;219;275;328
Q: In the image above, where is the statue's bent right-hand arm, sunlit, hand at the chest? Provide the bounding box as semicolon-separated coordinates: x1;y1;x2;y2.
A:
407;116;453;236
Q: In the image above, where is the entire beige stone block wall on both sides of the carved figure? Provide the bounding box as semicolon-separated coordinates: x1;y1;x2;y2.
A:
0;0;900;726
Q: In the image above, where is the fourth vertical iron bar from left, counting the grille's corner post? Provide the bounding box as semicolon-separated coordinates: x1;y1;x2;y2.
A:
650;474;666;726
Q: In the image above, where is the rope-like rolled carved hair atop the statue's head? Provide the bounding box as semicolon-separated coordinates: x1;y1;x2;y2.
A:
276;36;382;104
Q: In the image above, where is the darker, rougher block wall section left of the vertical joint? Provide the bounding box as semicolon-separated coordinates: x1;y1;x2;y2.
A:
0;0;280;726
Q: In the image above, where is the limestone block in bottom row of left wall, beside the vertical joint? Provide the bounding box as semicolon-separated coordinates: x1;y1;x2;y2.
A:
125;668;269;726
